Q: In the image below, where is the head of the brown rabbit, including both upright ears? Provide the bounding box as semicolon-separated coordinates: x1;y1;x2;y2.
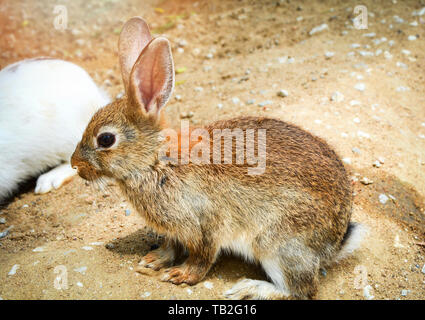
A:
71;17;174;180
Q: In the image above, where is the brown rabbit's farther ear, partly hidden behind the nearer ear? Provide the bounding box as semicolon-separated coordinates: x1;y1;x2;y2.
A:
118;17;152;92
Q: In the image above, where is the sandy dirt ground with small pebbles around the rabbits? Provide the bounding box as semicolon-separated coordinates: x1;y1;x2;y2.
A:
0;0;425;299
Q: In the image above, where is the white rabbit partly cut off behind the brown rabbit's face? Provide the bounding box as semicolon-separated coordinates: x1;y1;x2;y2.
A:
0;58;110;202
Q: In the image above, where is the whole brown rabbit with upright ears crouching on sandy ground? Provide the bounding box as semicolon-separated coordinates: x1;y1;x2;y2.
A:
72;18;364;299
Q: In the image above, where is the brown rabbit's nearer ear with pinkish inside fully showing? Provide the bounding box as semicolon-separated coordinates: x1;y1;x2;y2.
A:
129;37;174;117
